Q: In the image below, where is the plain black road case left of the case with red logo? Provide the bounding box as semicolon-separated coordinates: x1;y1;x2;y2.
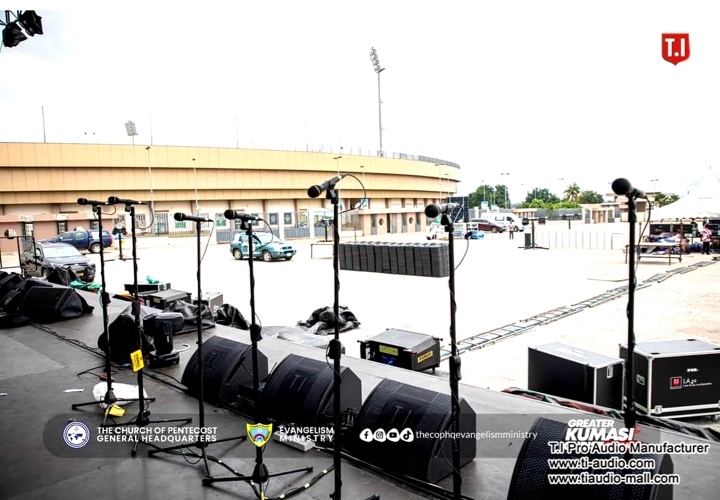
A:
528;342;624;410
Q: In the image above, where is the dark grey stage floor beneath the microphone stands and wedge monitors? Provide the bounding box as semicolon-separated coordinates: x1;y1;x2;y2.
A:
0;295;720;500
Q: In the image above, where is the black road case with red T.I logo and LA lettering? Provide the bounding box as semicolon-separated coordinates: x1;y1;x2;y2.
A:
620;339;720;418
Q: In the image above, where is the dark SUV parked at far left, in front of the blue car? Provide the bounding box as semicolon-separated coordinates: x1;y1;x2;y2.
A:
20;241;95;283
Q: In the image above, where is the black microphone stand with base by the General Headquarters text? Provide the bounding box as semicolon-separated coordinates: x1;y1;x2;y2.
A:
147;217;247;477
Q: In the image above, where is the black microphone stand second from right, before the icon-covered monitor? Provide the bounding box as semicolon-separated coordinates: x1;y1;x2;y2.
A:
440;213;462;500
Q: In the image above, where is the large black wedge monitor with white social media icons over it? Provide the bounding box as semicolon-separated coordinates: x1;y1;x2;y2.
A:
348;379;477;483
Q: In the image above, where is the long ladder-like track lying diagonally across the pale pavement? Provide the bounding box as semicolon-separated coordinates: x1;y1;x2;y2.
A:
440;260;717;361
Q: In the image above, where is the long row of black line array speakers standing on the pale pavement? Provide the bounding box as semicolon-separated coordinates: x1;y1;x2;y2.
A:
338;241;450;278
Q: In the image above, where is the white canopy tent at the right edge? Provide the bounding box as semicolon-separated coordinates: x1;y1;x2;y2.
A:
650;170;720;222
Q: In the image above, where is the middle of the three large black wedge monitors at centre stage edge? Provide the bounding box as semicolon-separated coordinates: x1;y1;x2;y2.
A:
260;354;362;426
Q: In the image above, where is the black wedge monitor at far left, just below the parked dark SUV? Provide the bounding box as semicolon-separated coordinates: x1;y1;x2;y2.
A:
18;286;86;323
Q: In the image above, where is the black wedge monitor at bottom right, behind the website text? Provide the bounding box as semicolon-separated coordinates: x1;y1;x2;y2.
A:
508;417;674;500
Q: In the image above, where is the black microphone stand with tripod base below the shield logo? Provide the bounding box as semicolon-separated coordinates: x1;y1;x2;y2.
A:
198;219;313;500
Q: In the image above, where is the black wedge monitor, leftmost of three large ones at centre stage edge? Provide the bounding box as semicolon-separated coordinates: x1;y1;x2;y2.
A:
182;336;268;414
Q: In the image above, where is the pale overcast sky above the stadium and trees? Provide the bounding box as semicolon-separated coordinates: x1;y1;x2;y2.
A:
0;0;720;202
